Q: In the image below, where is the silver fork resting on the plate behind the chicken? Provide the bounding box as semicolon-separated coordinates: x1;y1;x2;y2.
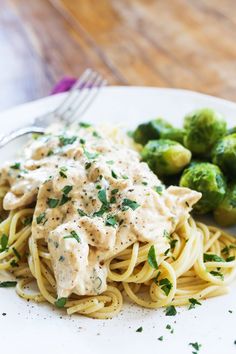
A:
0;69;106;148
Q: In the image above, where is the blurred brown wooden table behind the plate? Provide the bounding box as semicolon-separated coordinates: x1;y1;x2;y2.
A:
0;0;236;109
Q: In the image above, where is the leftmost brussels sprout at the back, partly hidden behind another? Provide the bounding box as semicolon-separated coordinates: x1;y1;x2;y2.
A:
133;118;172;145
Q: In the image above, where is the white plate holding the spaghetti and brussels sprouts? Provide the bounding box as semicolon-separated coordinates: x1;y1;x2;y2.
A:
0;87;236;354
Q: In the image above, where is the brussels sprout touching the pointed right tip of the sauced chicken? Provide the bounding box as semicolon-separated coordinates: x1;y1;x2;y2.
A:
180;162;226;214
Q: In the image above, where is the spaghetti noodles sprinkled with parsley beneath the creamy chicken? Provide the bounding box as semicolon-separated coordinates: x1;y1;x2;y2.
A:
0;201;236;319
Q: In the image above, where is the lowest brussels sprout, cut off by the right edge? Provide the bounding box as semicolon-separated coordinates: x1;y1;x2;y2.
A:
214;183;236;226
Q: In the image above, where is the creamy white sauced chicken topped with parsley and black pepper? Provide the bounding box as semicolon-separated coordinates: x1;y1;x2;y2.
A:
0;128;201;297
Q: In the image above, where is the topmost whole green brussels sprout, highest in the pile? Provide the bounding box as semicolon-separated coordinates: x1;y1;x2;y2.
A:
184;108;226;156
